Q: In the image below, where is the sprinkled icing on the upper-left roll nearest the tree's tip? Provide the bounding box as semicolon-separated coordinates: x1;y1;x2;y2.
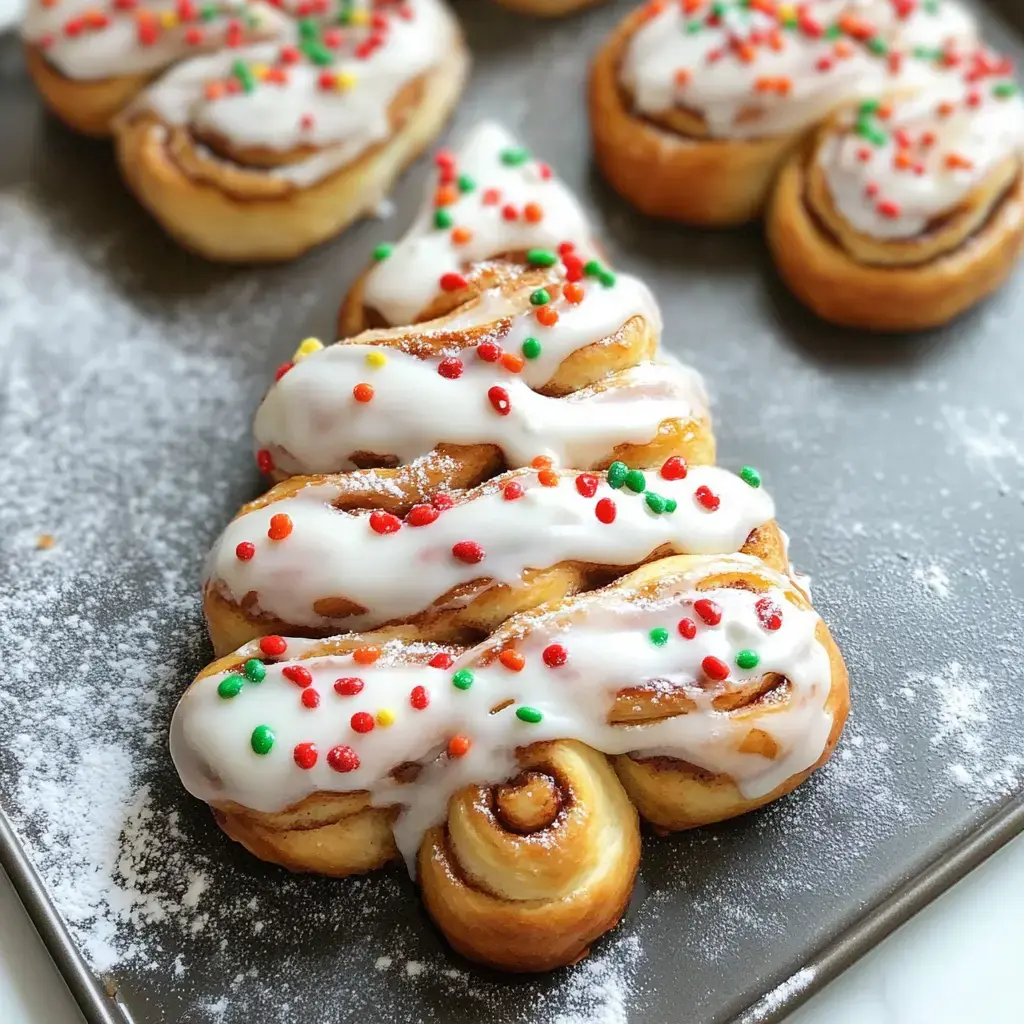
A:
125;0;457;185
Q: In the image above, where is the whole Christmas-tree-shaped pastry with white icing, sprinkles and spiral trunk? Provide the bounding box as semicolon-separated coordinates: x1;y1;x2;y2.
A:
171;124;849;971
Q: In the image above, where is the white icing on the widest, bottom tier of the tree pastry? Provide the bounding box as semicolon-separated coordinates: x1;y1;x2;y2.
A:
171;555;831;865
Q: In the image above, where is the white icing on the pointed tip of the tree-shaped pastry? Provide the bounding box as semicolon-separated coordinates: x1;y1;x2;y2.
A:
364;122;592;324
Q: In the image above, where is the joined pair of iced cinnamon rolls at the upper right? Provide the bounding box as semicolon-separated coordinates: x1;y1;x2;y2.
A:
590;0;1024;331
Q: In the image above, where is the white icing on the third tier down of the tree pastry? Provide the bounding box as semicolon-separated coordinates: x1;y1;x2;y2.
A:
207;466;774;631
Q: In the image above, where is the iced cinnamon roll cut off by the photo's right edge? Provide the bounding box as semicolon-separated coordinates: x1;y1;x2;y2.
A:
768;50;1024;331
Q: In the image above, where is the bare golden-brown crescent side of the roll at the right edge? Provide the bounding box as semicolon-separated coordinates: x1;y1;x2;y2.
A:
766;125;1024;331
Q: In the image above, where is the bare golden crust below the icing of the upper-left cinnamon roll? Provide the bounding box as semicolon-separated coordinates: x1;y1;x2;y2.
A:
115;42;469;262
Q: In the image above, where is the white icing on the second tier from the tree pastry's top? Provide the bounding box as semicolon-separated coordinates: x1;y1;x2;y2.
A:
254;274;707;474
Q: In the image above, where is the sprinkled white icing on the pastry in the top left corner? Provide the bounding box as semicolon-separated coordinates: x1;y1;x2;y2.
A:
22;0;287;81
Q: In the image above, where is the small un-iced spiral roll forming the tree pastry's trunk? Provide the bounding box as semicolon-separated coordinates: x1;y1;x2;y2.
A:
417;740;640;971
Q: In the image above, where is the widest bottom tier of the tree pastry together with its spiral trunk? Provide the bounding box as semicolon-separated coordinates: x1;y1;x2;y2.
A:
171;554;848;971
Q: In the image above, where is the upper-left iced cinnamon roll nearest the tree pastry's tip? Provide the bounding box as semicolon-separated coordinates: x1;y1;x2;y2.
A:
115;0;468;261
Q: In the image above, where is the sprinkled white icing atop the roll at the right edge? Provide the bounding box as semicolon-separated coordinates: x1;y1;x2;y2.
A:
816;57;1024;239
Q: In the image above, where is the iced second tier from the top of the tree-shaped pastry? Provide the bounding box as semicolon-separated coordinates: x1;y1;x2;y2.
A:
254;264;714;487
